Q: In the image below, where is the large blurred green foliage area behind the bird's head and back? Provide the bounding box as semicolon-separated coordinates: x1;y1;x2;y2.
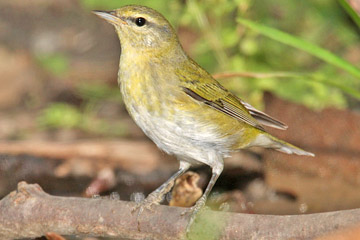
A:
81;0;360;109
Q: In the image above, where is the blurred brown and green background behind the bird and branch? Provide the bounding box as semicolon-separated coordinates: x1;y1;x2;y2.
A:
0;0;360;227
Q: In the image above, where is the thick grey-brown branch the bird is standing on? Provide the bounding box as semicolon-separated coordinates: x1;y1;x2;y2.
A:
0;182;360;239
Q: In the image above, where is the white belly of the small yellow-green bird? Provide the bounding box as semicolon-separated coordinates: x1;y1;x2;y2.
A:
127;105;230;165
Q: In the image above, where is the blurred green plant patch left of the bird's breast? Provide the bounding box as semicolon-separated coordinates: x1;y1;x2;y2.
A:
38;83;128;137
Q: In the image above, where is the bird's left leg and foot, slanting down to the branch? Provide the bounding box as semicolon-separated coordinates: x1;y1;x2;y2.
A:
133;161;190;217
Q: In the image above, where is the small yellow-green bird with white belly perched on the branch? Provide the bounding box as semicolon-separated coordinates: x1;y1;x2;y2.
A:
93;5;314;231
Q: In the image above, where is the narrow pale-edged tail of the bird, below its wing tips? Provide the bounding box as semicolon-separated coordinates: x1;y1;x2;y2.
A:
255;133;315;157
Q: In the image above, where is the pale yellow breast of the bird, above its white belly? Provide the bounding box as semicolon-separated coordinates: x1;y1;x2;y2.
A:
118;53;183;117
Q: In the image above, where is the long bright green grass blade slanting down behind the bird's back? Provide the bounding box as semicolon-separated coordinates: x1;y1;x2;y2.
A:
238;18;360;78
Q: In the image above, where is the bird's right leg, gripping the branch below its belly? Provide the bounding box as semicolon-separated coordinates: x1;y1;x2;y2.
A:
186;159;224;233
